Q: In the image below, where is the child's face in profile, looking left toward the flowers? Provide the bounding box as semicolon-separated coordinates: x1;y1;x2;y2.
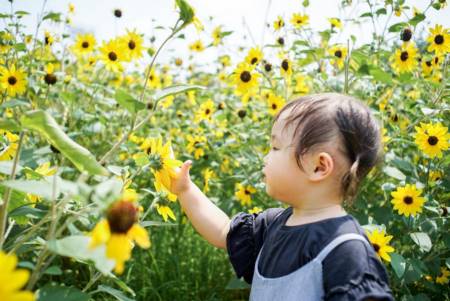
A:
263;110;311;204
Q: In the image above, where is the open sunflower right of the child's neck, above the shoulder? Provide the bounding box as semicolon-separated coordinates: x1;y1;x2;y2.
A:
391;184;425;217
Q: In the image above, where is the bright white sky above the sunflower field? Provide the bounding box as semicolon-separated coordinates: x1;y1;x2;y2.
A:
0;0;450;67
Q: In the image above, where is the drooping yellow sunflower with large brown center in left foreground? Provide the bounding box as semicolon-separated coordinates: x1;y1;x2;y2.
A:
89;189;150;274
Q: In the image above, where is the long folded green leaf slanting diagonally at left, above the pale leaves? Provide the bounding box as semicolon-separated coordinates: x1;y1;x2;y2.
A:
20;110;109;175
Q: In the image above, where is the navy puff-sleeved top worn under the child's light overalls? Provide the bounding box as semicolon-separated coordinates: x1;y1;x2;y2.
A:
227;207;394;301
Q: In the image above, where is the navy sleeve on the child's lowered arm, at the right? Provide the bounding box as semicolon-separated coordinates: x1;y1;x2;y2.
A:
323;240;394;301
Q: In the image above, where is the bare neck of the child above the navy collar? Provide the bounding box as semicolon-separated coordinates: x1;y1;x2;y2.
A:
286;204;347;226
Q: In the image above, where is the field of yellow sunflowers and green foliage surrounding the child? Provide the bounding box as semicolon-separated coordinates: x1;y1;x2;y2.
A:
0;0;450;301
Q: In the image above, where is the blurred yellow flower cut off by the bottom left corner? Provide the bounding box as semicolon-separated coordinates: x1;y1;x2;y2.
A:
0;250;36;301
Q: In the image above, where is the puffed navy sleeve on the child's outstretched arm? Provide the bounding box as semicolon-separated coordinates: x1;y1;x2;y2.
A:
226;208;284;283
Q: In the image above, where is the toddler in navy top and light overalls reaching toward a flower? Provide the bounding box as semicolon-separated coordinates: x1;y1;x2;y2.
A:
171;93;394;301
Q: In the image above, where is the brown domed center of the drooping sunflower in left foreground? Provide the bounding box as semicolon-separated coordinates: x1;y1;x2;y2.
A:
106;201;138;234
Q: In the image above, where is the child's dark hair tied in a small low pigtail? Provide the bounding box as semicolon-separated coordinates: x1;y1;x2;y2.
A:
274;93;383;204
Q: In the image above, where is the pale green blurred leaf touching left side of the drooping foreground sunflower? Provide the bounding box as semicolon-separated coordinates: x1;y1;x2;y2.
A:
47;235;115;275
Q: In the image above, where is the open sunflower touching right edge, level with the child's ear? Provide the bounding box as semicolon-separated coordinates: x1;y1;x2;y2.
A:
415;122;450;158
